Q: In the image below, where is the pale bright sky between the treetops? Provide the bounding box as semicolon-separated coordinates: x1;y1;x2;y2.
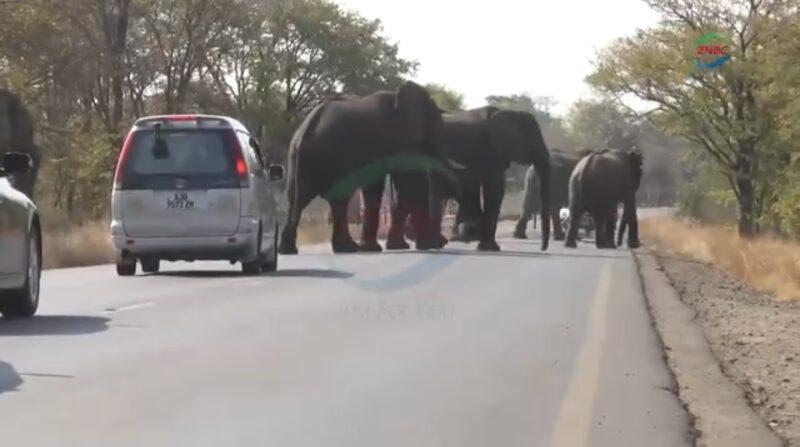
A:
336;0;658;114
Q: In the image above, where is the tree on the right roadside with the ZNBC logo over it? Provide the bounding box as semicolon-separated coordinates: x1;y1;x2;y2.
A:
588;0;798;236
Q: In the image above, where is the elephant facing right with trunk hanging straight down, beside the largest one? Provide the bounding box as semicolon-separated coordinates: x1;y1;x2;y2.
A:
387;106;550;251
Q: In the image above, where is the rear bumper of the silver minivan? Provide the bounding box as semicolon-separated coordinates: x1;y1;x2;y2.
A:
111;218;258;261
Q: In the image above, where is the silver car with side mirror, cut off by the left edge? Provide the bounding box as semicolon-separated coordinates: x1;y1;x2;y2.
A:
0;152;42;317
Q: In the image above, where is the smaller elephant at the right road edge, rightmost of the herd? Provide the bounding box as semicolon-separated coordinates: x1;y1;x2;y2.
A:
566;149;642;248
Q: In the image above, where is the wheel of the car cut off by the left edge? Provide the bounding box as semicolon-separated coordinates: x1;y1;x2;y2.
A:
0;229;42;318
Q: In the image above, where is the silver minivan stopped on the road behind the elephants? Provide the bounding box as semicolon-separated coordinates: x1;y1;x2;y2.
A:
111;115;284;276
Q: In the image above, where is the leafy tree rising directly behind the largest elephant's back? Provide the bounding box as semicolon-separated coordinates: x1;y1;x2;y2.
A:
256;0;417;156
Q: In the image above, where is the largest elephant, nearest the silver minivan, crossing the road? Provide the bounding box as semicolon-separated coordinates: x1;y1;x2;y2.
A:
279;82;442;254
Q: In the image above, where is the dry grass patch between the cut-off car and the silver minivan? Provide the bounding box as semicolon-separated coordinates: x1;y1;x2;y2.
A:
43;221;114;269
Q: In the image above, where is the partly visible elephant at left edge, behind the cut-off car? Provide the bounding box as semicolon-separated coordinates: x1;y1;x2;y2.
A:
0;89;41;198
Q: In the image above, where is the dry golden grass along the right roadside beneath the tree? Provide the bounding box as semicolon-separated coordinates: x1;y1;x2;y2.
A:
641;218;800;300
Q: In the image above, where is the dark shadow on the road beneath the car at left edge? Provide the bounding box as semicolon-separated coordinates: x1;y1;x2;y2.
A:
0;315;111;337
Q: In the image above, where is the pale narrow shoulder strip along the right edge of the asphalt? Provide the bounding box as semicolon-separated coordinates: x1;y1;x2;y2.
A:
635;250;783;447
